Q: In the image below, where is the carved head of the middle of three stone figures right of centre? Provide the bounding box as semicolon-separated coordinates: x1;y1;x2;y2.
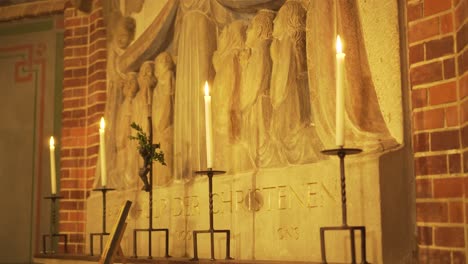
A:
245;9;275;47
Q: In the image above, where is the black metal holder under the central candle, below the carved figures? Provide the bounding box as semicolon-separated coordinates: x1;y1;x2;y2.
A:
191;168;233;261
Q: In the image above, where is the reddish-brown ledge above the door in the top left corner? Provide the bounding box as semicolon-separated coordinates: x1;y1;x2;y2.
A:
0;0;66;22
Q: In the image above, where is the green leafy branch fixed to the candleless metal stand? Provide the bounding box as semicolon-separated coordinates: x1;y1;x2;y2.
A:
128;122;166;165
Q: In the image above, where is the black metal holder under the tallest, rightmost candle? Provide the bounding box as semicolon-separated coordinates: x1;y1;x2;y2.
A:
320;147;368;264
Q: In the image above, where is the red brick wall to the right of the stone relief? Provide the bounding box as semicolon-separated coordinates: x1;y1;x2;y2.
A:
407;0;468;264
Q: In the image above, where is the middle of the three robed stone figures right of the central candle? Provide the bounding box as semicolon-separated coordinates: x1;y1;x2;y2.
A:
240;9;281;168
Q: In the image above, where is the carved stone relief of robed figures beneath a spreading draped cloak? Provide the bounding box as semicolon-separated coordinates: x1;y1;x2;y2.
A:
101;0;394;189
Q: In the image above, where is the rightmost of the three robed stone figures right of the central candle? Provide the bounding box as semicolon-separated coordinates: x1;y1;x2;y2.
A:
271;1;321;164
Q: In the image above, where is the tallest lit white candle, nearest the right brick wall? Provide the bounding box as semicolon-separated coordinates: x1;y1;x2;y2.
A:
336;36;345;146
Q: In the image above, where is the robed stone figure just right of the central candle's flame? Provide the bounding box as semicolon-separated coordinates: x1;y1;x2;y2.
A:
212;20;251;171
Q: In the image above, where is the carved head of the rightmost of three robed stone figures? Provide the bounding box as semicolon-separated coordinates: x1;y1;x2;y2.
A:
273;1;307;38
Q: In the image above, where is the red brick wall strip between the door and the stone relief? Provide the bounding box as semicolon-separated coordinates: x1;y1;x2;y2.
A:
59;0;107;254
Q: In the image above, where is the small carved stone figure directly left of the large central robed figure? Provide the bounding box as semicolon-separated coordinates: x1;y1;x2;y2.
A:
152;52;175;185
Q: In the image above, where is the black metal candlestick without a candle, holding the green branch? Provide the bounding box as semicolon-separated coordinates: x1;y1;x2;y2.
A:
133;116;170;259
